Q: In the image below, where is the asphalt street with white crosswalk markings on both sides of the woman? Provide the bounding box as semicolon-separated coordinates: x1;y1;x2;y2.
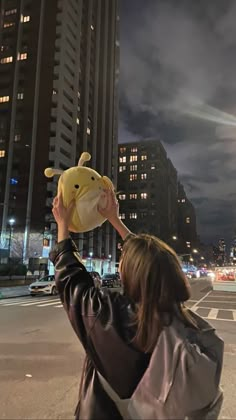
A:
0;280;236;420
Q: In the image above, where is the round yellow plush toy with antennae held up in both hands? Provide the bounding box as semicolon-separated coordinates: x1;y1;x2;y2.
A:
44;152;114;232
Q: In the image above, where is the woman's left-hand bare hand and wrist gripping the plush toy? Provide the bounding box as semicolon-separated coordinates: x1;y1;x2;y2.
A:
52;193;75;242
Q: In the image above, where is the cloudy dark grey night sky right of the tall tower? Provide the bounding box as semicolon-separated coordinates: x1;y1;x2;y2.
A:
119;0;236;243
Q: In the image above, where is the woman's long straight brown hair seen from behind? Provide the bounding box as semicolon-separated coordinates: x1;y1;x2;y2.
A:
120;234;194;352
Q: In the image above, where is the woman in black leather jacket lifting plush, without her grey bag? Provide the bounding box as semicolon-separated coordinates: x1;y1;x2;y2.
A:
50;190;194;420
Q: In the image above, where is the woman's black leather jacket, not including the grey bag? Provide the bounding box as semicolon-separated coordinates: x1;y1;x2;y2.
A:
50;239;150;420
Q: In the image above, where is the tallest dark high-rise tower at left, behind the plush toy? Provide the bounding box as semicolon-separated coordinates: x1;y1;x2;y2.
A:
0;0;119;257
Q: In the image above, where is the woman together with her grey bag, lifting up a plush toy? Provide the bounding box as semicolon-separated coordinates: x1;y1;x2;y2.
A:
50;191;223;420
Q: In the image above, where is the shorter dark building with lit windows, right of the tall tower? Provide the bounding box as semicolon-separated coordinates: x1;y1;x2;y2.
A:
118;140;177;243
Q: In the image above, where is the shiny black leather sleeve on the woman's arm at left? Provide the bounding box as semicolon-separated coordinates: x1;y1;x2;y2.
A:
50;239;99;349
